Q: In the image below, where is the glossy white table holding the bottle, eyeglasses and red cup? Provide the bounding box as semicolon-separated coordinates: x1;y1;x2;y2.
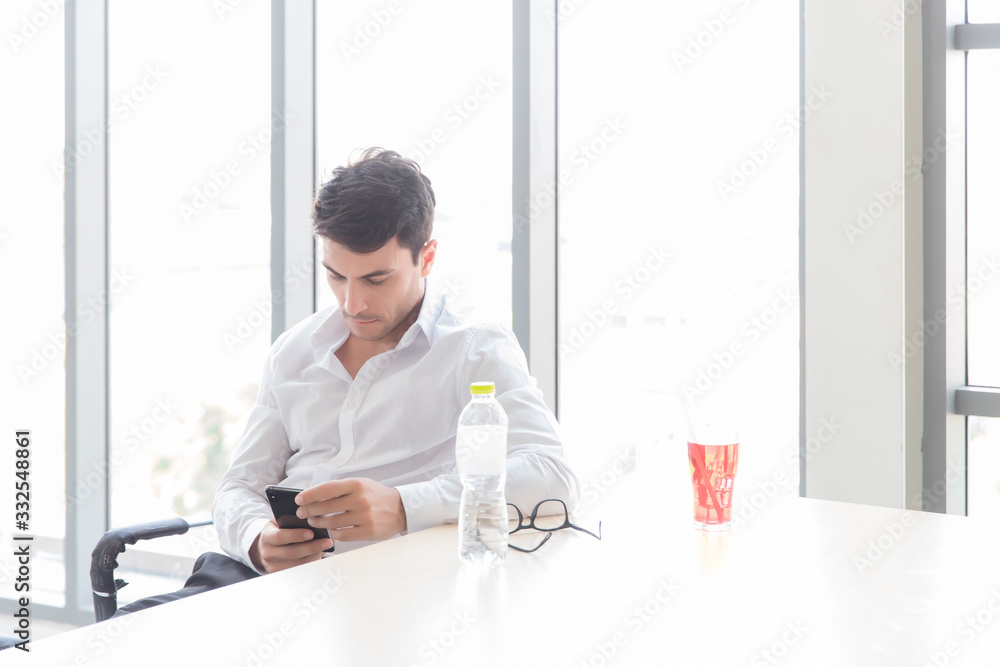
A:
11;479;1000;667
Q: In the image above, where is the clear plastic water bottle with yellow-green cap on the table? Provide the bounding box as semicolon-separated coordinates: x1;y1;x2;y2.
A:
455;382;507;565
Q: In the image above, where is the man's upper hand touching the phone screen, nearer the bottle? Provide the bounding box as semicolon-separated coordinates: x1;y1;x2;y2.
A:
295;477;406;541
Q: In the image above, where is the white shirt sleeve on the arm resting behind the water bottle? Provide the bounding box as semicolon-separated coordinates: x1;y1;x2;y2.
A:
396;325;579;532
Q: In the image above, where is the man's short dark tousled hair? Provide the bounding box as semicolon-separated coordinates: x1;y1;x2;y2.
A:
312;148;435;264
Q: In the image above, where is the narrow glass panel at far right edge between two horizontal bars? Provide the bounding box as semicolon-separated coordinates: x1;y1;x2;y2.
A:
958;50;1000;386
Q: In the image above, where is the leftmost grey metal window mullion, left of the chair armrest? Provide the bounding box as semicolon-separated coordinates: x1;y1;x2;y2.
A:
65;0;110;615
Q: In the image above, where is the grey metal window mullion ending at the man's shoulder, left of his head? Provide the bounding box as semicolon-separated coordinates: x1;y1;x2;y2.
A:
271;0;316;340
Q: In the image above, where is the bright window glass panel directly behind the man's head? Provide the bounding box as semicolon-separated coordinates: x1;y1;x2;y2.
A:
316;0;512;327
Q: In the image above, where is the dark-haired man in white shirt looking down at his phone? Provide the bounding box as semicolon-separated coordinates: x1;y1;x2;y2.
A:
213;148;577;573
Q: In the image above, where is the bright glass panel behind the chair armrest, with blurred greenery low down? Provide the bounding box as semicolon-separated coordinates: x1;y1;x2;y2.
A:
108;0;271;598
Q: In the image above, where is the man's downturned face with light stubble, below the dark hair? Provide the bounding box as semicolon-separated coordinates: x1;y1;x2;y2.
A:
320;237;437;341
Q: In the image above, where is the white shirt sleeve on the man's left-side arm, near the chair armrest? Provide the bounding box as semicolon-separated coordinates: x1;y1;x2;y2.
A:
212;354;292;574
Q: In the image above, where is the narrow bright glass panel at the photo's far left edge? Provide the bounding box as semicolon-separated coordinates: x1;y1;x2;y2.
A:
0;0;66;607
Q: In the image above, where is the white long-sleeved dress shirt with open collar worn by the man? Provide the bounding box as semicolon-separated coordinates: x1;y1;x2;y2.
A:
212;282;577;567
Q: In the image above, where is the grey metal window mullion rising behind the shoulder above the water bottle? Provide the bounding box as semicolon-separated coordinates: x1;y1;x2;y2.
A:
511;0;559;416
